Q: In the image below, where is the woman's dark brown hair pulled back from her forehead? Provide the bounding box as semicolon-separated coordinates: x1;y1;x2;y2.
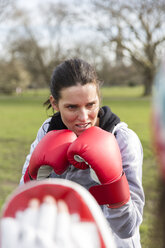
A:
44;58;100;108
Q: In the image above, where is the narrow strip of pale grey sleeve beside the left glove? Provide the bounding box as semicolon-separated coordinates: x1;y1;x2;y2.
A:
20;118;51;184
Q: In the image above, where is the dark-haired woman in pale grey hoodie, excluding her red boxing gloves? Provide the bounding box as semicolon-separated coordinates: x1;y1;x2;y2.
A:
21;59;144;248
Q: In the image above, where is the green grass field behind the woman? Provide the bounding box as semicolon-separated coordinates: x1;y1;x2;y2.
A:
0;87;161;248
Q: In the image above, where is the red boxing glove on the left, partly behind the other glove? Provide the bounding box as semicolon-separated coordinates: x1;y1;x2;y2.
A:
24;129;77;182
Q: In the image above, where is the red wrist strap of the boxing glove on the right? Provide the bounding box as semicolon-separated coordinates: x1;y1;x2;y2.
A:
89;172;130;208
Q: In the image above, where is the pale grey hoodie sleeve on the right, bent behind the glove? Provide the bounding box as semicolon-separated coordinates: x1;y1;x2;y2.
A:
104;124;144;239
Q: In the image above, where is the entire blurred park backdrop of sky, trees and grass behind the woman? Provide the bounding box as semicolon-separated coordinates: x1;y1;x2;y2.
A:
0;0;165;248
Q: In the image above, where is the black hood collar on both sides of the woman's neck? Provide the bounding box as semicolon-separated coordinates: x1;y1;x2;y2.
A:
47;106;120;132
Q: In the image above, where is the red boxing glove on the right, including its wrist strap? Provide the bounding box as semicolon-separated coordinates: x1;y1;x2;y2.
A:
67;127;130;208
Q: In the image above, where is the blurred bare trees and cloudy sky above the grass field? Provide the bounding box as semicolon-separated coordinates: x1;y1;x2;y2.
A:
0;0;165;95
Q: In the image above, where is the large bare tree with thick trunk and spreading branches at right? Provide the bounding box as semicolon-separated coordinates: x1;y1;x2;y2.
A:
92;0;165;95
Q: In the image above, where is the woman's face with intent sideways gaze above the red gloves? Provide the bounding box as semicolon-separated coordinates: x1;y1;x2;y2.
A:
50;83;99;136
